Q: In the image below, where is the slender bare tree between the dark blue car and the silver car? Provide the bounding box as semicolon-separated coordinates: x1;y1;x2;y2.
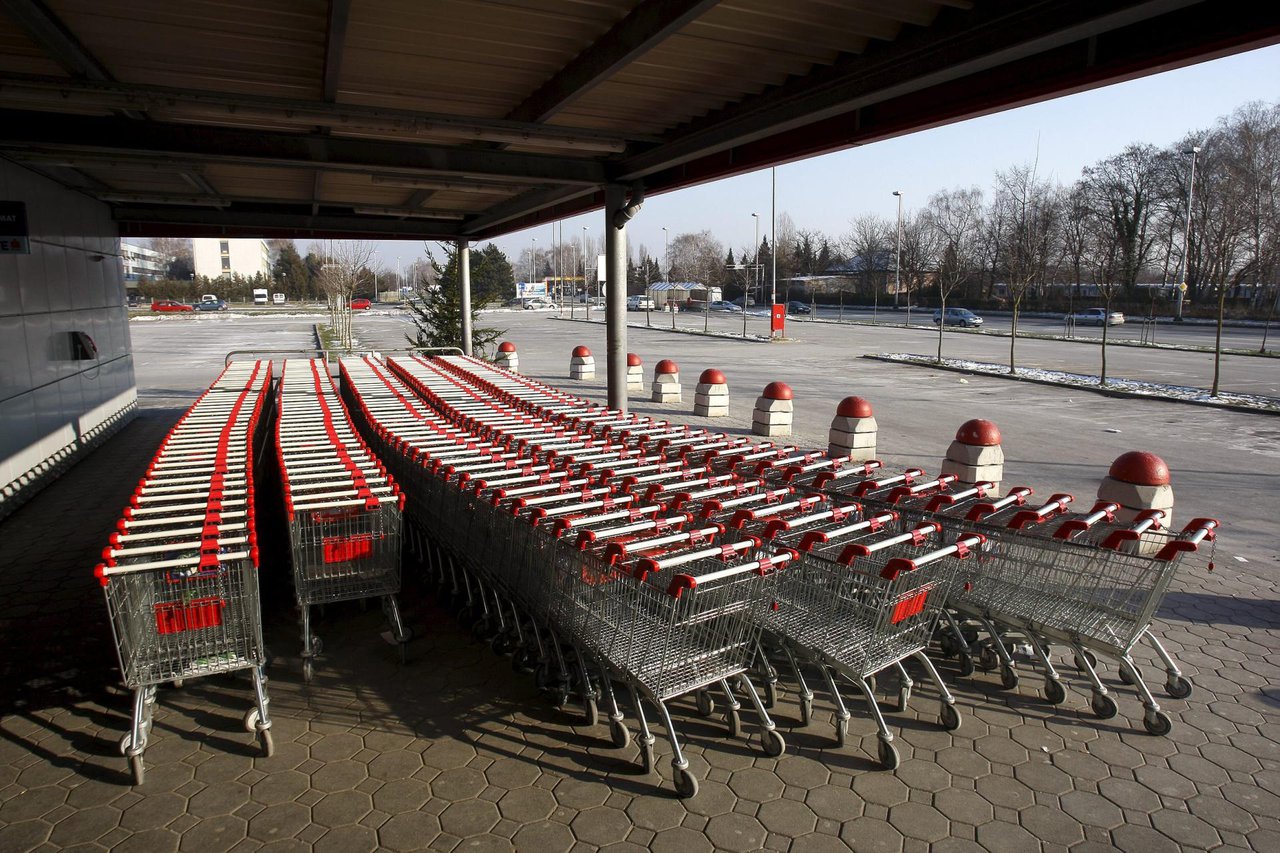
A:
996;163;1061;373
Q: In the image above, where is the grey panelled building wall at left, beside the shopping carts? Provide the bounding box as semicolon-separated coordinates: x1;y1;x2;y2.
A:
0;160;137;517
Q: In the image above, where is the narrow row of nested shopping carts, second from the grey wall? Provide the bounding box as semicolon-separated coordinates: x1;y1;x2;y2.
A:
275;359;410;681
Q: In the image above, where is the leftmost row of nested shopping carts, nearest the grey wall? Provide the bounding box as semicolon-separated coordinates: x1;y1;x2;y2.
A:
96;361;273;784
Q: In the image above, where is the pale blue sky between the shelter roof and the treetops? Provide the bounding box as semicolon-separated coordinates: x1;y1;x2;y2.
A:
358;46;1280;278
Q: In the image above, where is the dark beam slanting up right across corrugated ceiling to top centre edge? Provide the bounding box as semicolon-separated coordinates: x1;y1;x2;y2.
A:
507;0;718;122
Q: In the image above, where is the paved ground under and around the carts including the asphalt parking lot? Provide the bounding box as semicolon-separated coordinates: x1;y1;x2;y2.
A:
0;315;1280;853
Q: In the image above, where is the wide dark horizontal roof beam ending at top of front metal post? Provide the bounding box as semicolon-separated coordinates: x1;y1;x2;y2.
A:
0;110;605;186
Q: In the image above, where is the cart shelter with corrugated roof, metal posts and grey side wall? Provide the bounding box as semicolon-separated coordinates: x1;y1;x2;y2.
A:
0;0;1280;504
